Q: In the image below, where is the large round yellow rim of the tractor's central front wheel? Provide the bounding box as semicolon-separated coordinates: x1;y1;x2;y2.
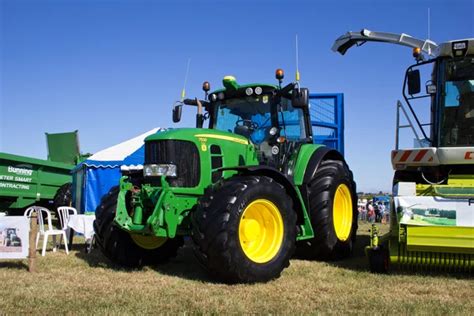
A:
239;199;284;263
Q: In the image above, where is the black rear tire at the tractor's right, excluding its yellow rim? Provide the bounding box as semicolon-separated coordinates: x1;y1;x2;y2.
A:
298;160;358;260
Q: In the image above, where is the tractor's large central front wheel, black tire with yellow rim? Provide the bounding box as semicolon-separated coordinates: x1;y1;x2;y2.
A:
192;176;296;283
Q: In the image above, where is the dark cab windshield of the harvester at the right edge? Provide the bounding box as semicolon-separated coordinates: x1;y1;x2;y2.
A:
440;57;474;146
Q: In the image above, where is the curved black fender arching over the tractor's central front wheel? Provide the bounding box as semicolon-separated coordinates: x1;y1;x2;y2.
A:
220;166;305;223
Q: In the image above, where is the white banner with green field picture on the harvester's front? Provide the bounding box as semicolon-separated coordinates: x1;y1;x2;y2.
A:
393;196;474;227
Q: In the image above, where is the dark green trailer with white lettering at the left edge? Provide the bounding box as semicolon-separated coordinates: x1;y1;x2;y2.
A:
0;131;87;214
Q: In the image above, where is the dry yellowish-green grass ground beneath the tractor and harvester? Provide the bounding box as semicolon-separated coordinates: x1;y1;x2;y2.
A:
0;225;474;315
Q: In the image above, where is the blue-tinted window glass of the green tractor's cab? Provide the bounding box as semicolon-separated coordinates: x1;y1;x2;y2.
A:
214;95;306;145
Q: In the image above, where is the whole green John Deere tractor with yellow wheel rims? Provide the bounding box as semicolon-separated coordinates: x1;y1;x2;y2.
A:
94;69;357;283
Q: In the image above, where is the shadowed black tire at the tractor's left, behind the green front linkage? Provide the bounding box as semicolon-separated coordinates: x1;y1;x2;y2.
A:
94;187;183;268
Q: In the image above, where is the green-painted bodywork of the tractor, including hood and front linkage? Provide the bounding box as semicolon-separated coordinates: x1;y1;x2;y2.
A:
115;78;348;247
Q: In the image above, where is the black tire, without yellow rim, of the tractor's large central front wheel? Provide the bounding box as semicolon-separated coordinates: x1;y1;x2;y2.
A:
192;176;296;283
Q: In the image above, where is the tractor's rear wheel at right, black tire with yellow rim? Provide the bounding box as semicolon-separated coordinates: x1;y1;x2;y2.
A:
298;160;358;260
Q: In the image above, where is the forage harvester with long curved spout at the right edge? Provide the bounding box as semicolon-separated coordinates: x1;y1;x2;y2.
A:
333;29;474;272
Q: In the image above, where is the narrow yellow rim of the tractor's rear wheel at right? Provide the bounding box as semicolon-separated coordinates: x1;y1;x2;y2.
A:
333;184;353;241
